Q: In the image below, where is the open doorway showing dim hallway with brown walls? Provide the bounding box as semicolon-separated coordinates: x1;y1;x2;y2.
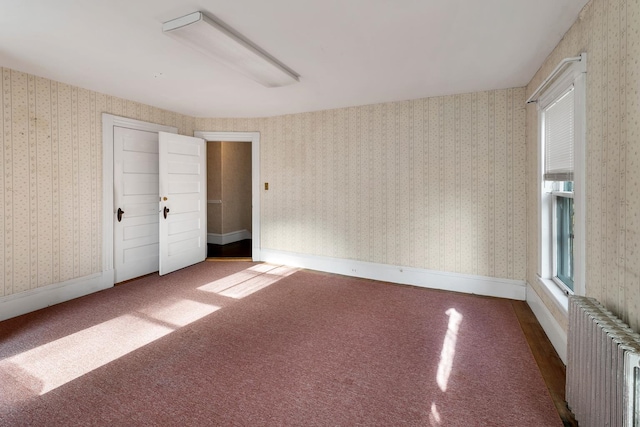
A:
207;141;252;259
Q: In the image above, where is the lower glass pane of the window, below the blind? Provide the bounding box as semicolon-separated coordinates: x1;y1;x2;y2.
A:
556;197;573;290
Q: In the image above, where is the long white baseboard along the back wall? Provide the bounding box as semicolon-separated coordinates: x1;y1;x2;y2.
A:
260;248;526;301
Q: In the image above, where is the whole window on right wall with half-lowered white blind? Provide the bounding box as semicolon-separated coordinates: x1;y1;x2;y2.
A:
538;55;586;294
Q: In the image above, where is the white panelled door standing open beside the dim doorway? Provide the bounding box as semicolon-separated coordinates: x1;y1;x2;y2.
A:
158;132;207;275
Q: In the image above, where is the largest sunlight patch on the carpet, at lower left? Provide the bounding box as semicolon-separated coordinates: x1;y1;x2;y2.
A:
0;300;220;395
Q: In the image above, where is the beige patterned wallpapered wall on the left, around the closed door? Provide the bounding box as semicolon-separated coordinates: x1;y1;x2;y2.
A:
0;68;195;296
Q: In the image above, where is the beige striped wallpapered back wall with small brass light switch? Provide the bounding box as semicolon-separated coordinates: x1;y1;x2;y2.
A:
196;88;526;280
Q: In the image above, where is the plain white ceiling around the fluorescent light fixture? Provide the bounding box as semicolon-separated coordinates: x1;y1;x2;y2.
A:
0;0;587;117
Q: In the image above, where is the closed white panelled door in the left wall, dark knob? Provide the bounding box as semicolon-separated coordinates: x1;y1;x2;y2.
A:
113;127;160;283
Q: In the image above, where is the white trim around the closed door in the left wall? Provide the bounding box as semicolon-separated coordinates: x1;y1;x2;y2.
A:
102;113;178;277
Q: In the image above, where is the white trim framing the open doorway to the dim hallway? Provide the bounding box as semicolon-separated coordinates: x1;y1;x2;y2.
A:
192;131;262;261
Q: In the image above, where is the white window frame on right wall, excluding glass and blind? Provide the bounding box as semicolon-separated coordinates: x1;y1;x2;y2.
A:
537;54;586;305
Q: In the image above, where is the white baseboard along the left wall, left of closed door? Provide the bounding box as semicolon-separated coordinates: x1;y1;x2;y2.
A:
0;270;113;321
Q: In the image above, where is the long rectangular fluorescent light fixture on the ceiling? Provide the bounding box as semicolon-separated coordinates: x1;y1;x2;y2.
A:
162;12;300;87
